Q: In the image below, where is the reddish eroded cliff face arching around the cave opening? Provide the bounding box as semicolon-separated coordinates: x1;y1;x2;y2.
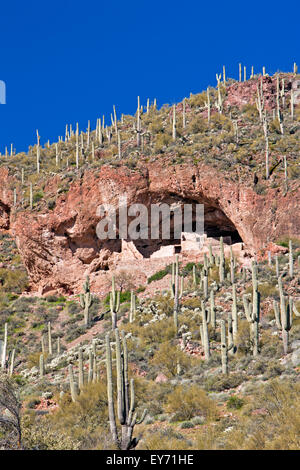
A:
0;163;300;293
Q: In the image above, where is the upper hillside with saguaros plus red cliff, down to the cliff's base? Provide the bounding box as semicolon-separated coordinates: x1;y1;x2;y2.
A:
0;68;300;293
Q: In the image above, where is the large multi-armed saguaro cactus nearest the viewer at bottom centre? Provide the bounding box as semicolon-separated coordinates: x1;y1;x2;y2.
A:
106;328;147;450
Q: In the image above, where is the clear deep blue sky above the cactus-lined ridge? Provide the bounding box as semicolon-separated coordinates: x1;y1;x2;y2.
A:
0;0;300;153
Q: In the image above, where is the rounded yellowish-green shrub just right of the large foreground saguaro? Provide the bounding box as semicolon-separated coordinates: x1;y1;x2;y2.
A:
166;385;217;421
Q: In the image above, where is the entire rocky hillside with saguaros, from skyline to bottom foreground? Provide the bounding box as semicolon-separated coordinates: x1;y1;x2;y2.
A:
0;65;300;450
